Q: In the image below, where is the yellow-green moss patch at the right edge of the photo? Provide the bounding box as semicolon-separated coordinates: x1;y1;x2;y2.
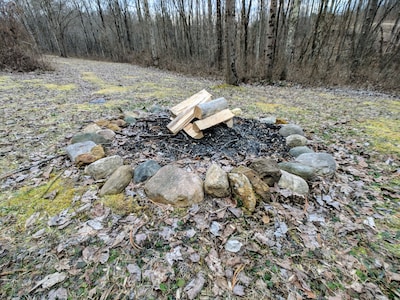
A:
362;118;400;156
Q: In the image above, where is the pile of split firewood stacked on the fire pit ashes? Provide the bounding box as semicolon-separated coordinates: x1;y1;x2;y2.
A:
167;90;234;139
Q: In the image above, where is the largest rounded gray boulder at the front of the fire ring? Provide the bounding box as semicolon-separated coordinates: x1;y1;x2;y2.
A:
144;165;204;207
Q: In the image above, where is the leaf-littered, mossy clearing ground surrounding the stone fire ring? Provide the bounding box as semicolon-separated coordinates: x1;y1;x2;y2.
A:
0;58;400;299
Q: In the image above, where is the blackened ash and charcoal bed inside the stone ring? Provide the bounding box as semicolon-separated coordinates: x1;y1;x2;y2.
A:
112;113;289;165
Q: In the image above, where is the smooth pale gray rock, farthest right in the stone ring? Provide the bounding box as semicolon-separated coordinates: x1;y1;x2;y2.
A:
295;153;336;176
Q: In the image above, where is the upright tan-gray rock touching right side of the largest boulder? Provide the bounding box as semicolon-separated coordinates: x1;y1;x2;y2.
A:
204;164;231;198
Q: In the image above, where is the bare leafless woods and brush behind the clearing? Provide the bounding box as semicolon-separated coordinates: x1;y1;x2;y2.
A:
0;0;400;93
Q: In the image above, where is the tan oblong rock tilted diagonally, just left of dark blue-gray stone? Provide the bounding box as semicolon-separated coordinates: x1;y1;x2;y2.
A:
100;166;133;196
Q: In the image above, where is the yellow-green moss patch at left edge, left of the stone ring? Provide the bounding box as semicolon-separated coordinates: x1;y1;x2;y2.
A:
0;178;77;230
